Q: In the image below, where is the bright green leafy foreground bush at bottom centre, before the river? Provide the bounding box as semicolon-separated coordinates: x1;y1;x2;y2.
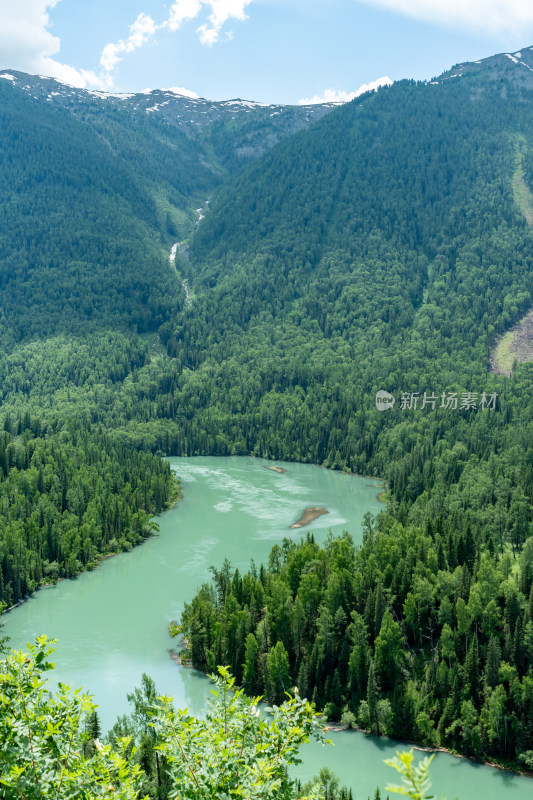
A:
154;667;324;800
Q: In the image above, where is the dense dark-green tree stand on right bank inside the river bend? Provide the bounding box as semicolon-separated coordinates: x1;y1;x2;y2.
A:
181;532;533;769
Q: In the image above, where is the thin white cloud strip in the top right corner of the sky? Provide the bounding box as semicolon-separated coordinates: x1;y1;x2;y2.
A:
359;0;533;35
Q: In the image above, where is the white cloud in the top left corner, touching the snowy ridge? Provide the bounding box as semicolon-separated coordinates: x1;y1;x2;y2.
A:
0;0;107;89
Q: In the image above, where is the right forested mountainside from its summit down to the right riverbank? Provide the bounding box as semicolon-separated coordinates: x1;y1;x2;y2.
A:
168;53;533;767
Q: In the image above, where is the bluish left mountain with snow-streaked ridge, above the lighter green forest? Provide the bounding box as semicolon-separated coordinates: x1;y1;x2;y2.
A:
0;71;331;346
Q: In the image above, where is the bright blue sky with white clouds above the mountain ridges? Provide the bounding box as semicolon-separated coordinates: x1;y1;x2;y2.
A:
0;0;533;103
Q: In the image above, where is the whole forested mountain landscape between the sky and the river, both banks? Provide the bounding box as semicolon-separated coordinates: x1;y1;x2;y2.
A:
0;48;533;767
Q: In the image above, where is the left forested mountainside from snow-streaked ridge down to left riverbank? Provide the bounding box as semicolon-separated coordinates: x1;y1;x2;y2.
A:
0;71;332;607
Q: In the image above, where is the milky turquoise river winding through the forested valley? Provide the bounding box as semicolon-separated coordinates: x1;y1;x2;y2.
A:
1;457;533;800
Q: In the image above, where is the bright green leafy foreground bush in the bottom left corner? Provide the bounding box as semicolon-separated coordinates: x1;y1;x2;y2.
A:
0;636;145;800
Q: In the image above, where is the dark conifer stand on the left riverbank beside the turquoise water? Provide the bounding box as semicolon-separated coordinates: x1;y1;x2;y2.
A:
0;414;178;609
